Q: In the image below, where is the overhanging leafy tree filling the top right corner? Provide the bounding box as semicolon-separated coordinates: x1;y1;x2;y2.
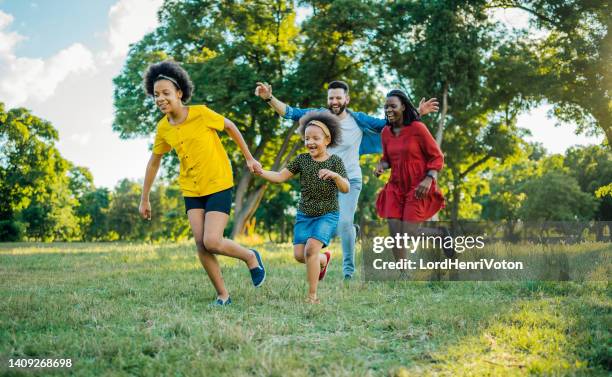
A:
489;0;612;146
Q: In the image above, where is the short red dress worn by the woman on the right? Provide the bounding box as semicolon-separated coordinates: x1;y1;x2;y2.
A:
376;121;444;222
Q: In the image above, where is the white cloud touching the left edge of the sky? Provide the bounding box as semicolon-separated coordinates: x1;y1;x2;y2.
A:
0;11;94;107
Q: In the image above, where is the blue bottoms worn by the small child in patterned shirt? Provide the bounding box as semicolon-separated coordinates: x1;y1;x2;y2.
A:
293;211;340;247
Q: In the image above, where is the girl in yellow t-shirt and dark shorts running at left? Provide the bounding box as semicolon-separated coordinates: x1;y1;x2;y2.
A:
139;61;266;305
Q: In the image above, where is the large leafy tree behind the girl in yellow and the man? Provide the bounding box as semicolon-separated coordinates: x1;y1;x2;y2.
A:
113;0;375;235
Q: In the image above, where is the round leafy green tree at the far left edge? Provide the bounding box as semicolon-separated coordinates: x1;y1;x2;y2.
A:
0;103;79;240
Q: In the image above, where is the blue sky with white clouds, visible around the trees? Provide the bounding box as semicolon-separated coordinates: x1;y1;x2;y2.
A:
0;0;603;187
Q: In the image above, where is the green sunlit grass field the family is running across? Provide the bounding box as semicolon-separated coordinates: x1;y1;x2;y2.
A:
0;243;612;377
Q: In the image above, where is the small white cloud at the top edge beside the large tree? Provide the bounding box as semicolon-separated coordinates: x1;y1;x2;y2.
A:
108;0;163;58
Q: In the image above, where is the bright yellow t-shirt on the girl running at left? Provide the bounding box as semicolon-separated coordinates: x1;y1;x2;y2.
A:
153;105;234;196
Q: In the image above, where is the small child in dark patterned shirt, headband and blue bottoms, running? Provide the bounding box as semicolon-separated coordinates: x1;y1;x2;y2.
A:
255;111;350;304
